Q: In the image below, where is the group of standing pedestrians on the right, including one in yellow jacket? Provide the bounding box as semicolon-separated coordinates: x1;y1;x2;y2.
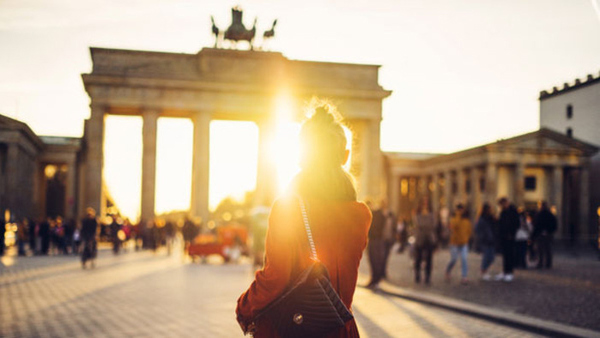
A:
367;197;557;288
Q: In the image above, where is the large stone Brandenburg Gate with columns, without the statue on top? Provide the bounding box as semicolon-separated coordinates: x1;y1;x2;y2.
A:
78;48;391;220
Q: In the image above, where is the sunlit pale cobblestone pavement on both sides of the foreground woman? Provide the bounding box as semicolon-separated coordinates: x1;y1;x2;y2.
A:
0;246;531;337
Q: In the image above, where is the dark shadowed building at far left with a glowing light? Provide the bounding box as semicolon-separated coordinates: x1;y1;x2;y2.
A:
0;115;81;219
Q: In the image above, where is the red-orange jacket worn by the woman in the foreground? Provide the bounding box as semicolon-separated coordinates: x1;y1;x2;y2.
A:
236;198;371;337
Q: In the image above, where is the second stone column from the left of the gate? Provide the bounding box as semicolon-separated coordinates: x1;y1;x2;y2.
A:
141;109;159;221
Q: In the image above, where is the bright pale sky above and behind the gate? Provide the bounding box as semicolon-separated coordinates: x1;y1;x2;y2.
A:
0;0;600;219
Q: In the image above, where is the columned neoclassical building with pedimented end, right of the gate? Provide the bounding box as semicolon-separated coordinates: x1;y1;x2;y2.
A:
386;128;598;241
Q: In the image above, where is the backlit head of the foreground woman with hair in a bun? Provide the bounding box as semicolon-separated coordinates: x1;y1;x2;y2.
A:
293;103;356;200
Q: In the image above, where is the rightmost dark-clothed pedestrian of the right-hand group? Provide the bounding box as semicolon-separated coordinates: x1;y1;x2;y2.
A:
532;201;558;269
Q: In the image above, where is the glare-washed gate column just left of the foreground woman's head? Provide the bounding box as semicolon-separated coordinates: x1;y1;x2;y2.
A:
255;119;277;205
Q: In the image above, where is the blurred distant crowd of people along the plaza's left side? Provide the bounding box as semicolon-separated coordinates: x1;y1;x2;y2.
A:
0;208;206;268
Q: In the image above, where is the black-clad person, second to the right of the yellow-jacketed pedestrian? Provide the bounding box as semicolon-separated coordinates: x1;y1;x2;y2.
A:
495;197;521;282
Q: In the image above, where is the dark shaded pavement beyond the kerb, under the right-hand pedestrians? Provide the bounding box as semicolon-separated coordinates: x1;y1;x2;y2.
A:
361;244;600;331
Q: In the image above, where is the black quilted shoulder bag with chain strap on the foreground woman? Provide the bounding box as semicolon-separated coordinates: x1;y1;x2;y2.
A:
254;198;354;337
